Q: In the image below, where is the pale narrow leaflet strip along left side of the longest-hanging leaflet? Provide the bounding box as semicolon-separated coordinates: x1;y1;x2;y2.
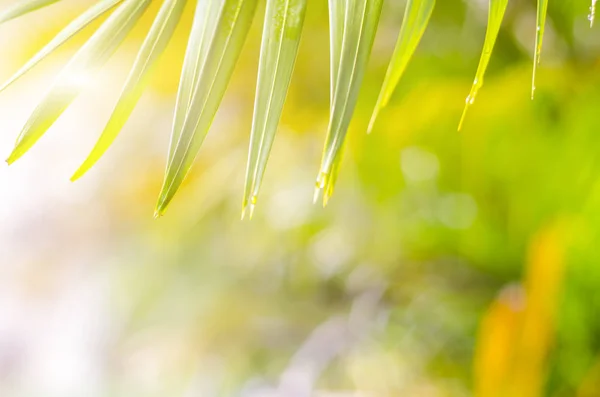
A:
167;0;224;164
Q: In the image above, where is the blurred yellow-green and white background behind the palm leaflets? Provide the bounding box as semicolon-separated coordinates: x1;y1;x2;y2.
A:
0;0;600;397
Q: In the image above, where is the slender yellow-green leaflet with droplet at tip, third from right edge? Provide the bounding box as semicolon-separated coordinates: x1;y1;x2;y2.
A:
458;0;508;131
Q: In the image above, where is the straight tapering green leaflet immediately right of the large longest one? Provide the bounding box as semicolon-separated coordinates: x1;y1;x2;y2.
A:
242;0;306;218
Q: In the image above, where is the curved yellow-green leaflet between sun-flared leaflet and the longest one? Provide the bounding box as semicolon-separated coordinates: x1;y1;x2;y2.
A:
71;0;187;181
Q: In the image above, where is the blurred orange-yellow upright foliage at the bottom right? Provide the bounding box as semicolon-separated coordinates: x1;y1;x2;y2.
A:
474;221;568;397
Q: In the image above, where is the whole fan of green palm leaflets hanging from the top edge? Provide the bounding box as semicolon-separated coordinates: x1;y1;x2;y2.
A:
0;0;580;215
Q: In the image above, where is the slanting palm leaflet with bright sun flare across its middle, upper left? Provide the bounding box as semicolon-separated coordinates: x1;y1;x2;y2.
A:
7;0;151;164
